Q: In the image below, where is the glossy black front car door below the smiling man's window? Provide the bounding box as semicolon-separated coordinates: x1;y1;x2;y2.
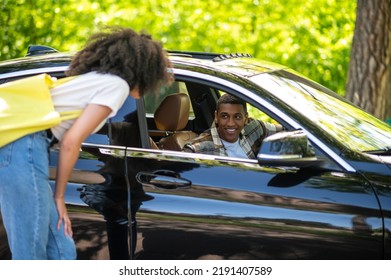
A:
125;72;383;259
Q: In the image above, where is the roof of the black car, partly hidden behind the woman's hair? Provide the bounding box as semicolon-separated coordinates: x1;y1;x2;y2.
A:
0;49;286;79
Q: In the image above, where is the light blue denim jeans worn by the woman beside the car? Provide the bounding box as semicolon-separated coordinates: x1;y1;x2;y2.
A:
0;132;76;260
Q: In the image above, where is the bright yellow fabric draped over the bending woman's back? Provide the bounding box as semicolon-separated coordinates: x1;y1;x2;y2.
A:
0;74;81;147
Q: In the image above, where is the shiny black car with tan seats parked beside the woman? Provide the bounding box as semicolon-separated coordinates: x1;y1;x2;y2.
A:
0;47;391;260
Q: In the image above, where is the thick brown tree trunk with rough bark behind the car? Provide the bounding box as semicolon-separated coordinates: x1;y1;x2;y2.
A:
346;0;391;121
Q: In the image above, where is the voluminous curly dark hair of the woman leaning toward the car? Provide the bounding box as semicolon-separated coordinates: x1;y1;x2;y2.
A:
66;27;173;96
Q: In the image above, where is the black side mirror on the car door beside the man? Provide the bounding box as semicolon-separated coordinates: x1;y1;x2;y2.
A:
257;130;323;168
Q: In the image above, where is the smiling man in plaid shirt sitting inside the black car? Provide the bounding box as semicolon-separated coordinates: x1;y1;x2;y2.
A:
183;94;283;159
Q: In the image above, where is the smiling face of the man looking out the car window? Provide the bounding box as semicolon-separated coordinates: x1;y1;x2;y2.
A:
215;104;247;143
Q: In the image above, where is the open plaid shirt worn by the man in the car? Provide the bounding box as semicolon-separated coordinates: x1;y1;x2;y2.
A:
183;119;282;159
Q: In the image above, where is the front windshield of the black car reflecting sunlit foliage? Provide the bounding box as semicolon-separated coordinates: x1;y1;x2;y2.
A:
251;71;391;152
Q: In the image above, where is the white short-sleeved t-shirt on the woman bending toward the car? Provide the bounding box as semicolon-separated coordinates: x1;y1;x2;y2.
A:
50;72;129;140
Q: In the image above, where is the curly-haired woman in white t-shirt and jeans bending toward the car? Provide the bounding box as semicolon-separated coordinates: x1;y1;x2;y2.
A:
0;28;172;259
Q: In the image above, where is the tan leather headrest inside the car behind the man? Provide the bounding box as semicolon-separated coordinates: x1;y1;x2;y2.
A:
154;93;190;131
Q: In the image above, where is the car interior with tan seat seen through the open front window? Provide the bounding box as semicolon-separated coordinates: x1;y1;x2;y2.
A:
144;80;284;151
